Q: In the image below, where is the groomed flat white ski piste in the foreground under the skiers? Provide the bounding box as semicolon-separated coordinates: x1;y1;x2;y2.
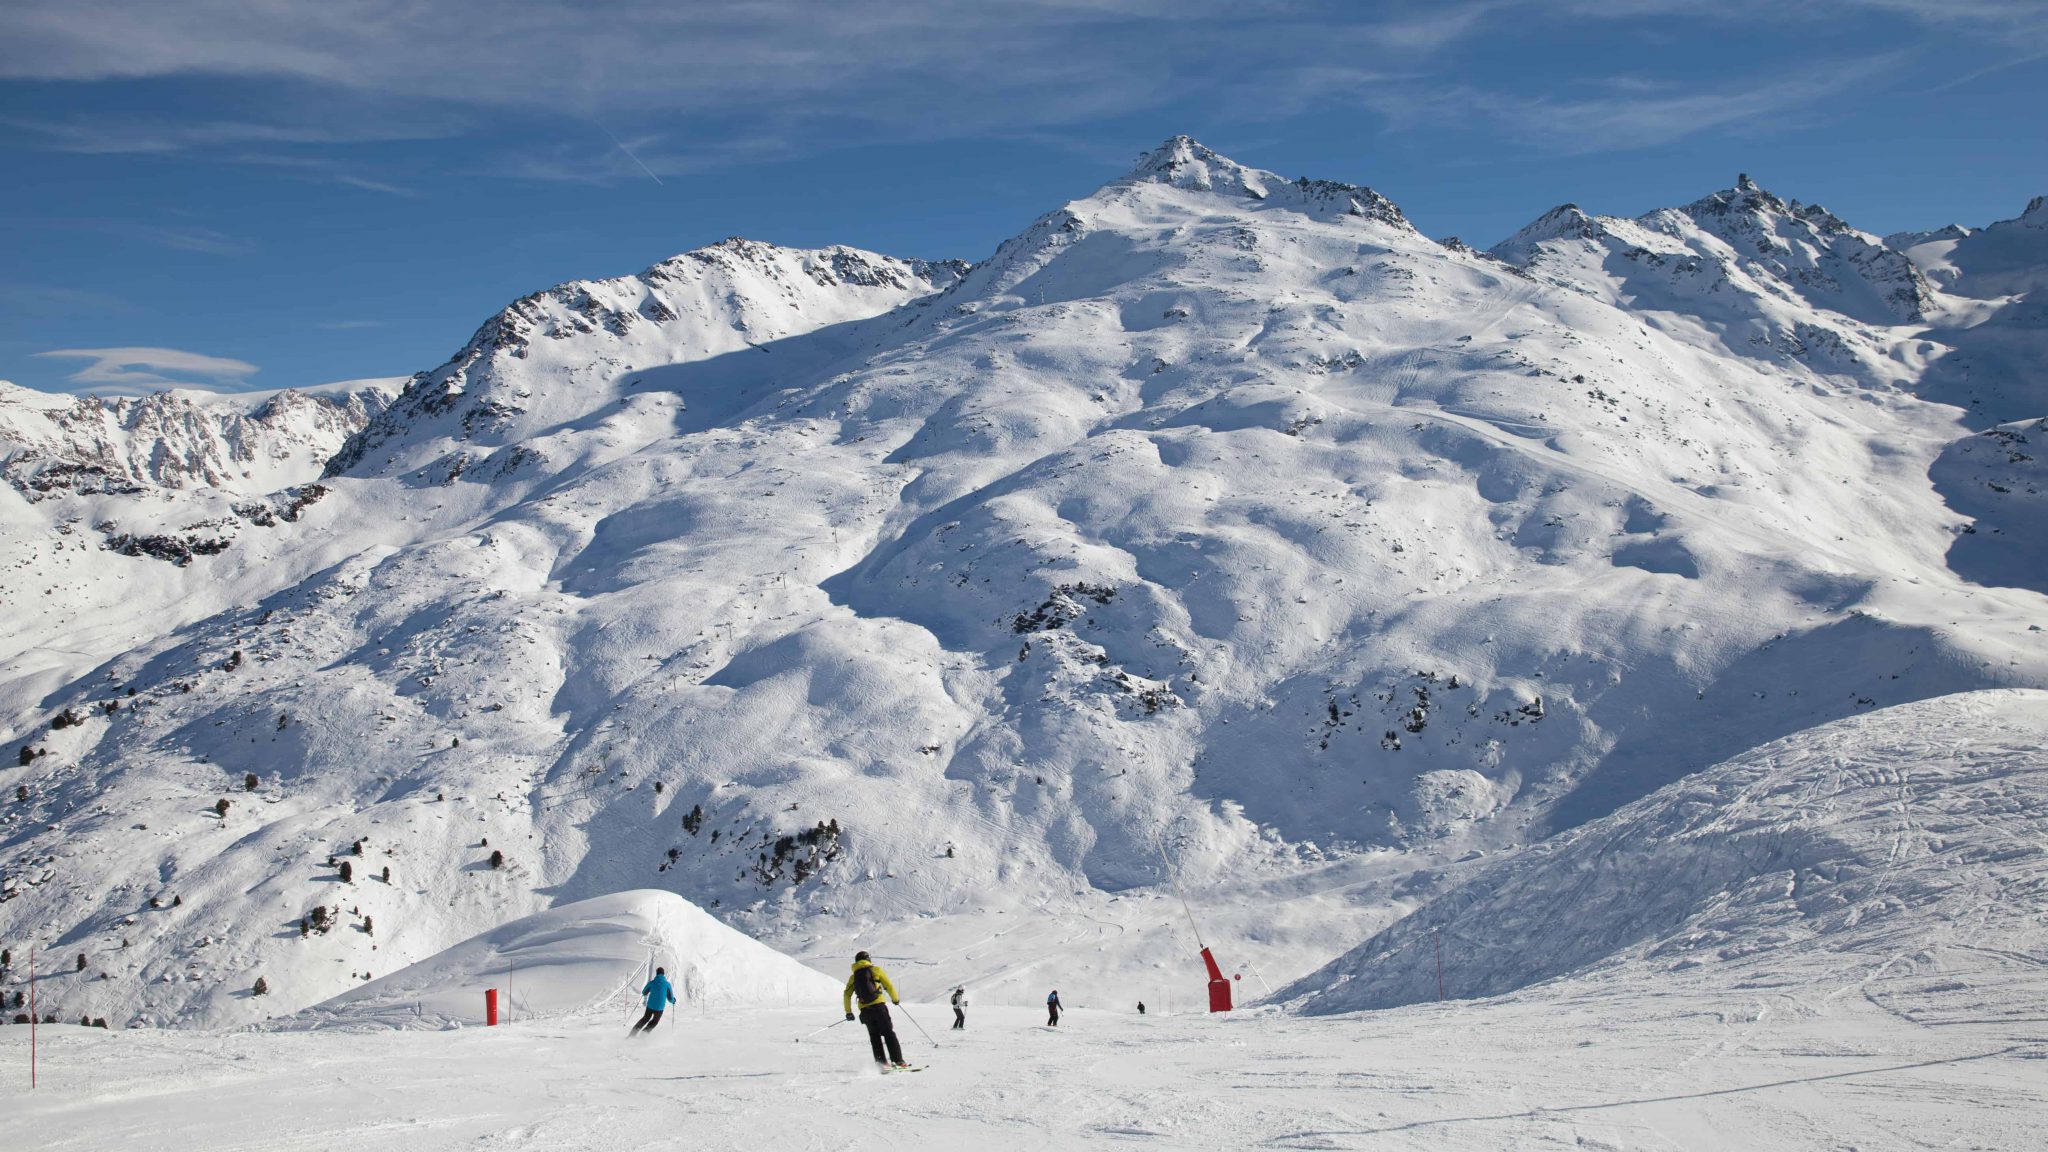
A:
0;986;2048;1152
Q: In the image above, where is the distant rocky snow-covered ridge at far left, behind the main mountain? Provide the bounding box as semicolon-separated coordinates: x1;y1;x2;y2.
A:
0;379;403;717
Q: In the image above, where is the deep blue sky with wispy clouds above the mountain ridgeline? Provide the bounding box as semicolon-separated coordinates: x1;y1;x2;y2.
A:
0;0;2048;394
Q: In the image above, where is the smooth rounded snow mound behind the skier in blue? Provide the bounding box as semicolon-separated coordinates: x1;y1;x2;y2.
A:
279;890;840;1027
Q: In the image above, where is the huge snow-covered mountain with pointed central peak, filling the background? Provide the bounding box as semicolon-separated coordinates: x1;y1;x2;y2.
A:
0;137;2048;1023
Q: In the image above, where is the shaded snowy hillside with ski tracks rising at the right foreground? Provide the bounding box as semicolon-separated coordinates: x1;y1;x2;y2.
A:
1280;691;2048;1017
